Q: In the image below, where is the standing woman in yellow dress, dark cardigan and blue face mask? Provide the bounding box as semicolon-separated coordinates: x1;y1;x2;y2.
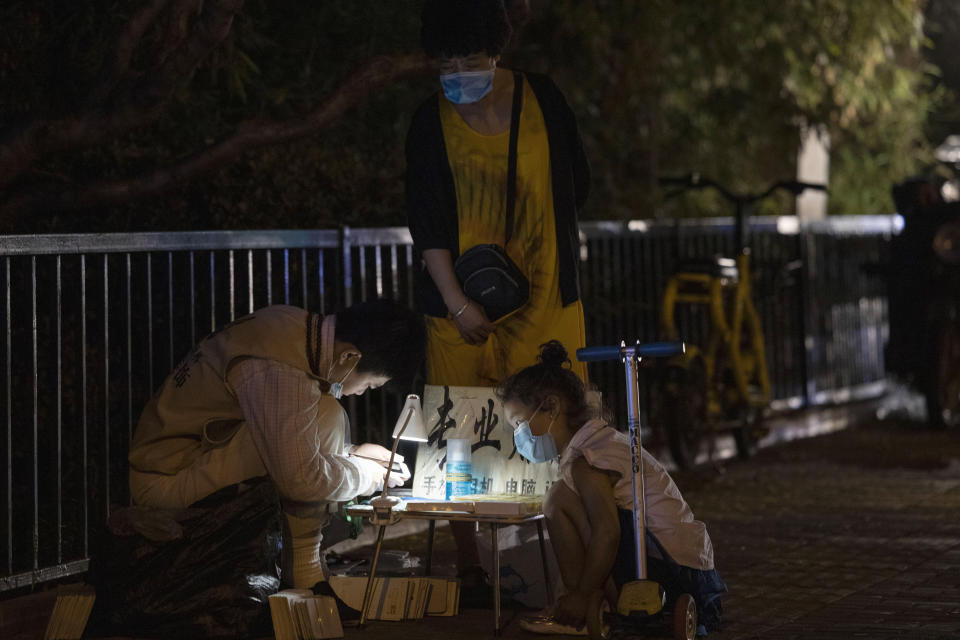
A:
406;0;590;386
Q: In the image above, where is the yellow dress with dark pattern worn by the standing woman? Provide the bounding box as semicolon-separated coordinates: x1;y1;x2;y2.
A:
426;75;587;387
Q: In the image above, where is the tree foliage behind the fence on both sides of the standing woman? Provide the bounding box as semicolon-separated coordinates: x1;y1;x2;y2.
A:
0;0;939;232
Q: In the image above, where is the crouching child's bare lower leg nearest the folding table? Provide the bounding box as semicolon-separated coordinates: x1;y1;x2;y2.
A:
543;482;590;591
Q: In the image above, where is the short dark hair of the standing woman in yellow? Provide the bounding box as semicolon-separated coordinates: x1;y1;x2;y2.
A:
420;0;510;58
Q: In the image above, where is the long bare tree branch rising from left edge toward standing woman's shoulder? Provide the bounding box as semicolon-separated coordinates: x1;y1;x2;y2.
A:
0;54;430;222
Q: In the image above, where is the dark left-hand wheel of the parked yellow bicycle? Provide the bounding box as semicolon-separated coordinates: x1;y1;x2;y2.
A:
654;357;709;469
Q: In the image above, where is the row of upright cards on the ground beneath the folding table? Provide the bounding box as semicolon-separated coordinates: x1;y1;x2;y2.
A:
330;576;460;620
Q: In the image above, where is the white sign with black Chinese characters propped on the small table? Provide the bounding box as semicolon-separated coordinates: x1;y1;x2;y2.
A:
413;385;559;499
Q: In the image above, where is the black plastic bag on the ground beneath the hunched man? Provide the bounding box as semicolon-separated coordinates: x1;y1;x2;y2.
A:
89;480;283;638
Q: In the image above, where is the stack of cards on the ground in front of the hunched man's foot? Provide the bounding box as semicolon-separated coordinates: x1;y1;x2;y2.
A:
270;589;343;640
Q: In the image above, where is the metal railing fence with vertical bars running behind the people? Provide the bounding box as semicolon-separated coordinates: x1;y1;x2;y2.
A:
0;216;897;592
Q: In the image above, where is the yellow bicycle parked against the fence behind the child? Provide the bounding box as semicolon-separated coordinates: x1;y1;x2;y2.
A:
652;174;825;468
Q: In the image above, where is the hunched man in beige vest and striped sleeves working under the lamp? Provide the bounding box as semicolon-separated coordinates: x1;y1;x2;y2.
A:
129;300;425;588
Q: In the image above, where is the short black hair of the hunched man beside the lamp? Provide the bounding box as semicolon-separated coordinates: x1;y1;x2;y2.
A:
334;299;427;385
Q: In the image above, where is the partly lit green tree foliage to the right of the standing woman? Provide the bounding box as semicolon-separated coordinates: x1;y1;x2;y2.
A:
512;0;936;217
